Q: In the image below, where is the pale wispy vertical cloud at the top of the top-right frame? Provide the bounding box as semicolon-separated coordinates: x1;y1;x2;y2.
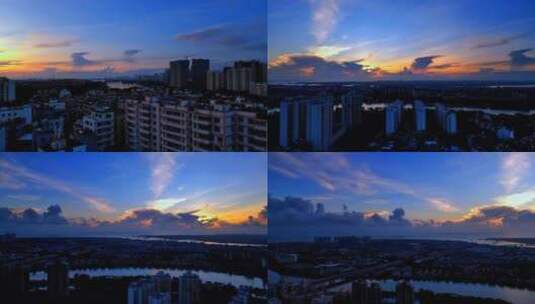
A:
310;0;340;44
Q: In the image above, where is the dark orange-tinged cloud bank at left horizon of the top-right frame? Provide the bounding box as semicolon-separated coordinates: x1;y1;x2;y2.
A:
269;54;376;81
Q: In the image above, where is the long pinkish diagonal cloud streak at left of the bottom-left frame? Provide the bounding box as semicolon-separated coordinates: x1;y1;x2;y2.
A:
0;160;115;213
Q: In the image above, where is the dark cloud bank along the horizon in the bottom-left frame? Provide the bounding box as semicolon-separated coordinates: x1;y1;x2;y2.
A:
0;205;267;236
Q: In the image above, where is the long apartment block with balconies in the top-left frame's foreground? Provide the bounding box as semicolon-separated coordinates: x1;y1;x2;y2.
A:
126;98;267;152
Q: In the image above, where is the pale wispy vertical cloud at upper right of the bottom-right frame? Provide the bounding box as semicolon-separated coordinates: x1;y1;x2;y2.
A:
500;153;531;192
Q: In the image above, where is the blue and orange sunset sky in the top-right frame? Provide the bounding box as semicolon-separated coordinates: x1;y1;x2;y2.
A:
268;0;535;82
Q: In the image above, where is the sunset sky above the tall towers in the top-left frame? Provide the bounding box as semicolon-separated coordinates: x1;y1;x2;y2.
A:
0;0;267;78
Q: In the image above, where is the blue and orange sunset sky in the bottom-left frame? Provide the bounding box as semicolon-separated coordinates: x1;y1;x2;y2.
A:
0;153;267;236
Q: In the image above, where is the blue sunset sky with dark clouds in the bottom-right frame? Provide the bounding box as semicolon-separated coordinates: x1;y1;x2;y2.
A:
268;153;535;239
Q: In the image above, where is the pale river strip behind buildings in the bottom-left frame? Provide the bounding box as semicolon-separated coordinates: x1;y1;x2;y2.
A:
30;268;264;288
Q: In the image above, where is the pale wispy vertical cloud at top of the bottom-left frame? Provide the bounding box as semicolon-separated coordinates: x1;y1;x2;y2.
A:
149;153;178;199
